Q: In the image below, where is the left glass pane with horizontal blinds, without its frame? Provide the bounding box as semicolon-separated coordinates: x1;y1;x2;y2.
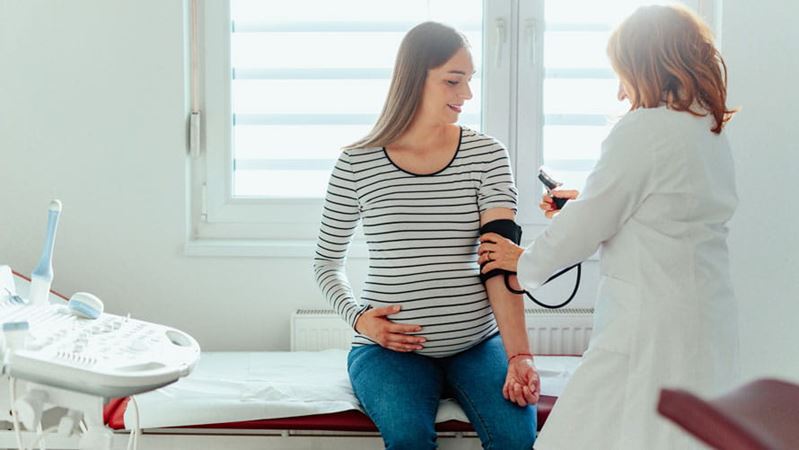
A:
230;0;483;198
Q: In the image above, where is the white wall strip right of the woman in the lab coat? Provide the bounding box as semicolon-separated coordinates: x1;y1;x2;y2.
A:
722;0;799;379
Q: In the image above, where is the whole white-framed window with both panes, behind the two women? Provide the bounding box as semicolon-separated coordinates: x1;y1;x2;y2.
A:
190;0;713;251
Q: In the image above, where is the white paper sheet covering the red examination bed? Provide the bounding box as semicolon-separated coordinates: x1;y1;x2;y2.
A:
125;350;580;428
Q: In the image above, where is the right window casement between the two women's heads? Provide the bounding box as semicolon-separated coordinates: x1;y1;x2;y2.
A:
513;0;713;223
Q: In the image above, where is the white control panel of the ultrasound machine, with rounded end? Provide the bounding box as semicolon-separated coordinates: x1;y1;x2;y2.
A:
0;266;200;398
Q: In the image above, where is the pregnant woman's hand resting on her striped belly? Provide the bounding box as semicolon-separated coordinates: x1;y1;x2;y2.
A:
355;305;427;352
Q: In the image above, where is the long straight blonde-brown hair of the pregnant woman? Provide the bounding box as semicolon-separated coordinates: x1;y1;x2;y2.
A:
344;22;469;150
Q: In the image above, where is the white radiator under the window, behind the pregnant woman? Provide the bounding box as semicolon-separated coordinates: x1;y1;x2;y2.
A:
291;308;594;355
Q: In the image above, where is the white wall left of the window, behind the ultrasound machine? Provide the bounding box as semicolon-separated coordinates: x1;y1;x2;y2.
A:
0;0;310;349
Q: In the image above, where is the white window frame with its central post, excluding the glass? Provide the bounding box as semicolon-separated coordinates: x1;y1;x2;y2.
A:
186;0;721;258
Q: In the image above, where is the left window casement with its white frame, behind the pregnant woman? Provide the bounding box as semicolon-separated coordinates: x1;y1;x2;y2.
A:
191;0;496;246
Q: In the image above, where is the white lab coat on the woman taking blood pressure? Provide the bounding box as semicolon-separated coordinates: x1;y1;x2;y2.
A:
518;107;738;450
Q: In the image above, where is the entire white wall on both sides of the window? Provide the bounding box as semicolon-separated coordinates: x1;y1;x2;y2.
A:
0;0;799;378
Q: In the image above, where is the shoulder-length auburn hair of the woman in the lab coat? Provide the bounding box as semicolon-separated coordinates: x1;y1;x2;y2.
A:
607;5;737;134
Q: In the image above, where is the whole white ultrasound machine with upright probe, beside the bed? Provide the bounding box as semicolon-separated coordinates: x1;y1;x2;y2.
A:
0;200;200;450
